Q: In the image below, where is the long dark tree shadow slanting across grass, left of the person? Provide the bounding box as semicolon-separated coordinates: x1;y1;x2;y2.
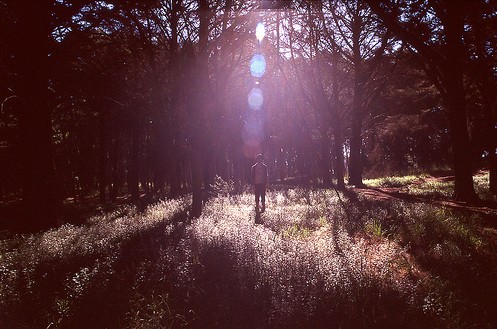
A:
62;211;194;328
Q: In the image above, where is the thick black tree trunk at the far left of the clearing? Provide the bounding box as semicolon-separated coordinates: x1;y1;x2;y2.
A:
11;0;59;229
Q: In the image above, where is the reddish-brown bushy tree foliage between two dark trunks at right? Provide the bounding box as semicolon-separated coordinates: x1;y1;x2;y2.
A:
365;48;450;175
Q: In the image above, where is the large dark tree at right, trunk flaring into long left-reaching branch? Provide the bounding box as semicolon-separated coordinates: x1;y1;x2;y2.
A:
368;0;479;201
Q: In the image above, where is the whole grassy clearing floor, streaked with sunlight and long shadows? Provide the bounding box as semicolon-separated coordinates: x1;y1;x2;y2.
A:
0;173;497;328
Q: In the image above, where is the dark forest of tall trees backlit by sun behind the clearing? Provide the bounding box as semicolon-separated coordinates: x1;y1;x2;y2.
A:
0;0;497;226
